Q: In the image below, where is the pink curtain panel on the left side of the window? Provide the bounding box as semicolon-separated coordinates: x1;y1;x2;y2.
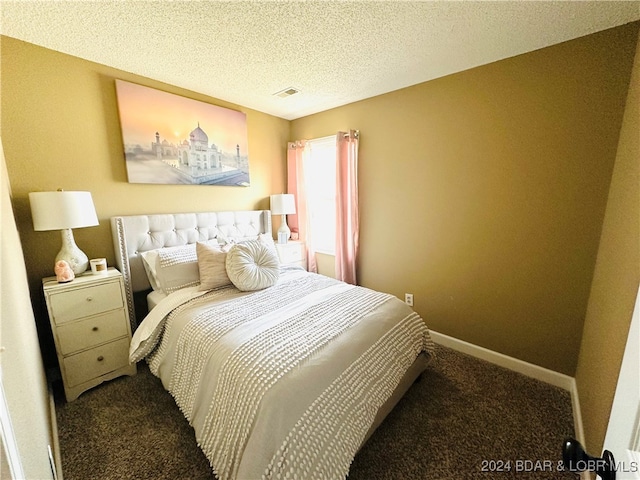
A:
287;140;318;273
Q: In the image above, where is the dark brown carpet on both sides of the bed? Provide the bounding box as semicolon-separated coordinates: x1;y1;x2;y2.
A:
54;346;577;480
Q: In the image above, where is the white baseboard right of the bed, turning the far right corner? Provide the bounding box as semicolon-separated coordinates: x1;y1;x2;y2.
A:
430;330;584;445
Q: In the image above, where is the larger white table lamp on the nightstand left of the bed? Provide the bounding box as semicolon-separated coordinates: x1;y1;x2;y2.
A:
29;190;98;275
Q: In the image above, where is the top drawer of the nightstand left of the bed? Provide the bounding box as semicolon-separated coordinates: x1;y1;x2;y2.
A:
50;282;124;324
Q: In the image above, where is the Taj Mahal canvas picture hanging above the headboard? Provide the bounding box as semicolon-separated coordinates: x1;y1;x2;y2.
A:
116;80;249;187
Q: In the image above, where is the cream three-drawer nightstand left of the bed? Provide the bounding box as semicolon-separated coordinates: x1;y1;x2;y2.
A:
42;268;136;401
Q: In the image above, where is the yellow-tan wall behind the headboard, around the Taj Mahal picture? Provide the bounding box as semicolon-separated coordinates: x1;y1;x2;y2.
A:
1;37;290;359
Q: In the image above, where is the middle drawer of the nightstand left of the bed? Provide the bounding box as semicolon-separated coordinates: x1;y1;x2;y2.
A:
56;309;129;355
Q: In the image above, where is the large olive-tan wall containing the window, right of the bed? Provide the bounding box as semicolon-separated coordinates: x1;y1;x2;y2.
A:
291;24;638;375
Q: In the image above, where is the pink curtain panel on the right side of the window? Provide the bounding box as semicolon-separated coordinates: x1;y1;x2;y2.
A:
336;130;360;285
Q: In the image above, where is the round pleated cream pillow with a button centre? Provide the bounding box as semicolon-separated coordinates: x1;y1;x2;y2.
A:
226;240;280;292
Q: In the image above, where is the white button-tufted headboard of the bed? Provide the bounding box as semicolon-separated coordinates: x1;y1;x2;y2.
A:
111;210;271;330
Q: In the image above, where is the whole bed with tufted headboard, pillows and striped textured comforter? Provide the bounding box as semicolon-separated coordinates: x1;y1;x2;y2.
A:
111;210;433;480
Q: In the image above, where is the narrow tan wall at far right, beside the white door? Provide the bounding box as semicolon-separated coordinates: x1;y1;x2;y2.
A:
576;31;640;454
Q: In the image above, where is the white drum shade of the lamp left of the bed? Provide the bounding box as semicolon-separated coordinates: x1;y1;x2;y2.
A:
29;191;98;231
